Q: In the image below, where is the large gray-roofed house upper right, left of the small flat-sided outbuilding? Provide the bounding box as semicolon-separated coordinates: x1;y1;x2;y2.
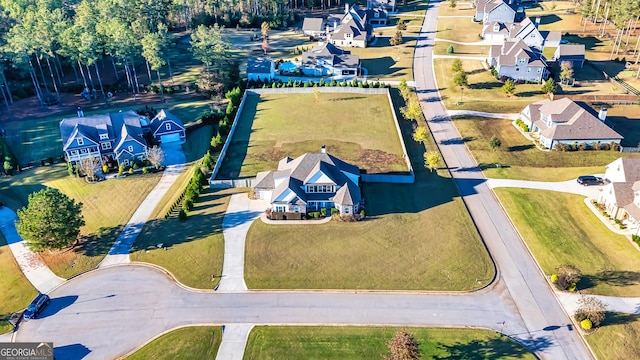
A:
487;39;549;83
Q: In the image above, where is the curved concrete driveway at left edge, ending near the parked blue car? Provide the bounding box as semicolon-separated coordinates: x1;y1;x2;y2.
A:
0;206;66;293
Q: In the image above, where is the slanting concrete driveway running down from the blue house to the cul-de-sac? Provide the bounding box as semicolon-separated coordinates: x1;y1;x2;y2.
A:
98;164;185;267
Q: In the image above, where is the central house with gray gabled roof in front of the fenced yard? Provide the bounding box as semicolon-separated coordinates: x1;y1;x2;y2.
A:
254;146;362;215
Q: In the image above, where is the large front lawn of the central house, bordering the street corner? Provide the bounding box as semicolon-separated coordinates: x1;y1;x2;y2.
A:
245;174;493;291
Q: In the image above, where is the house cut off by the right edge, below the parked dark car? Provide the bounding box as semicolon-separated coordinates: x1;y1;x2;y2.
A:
598;157;640;234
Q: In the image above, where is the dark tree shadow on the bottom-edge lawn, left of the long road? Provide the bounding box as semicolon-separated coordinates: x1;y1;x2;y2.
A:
434;336;551;359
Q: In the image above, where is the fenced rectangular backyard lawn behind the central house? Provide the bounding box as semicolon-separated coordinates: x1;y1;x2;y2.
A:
218;93;407;178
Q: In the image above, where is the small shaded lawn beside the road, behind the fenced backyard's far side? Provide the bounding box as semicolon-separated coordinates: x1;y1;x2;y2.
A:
349;38;416;81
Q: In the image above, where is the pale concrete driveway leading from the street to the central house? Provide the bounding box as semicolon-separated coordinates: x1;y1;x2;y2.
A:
216;193;269;292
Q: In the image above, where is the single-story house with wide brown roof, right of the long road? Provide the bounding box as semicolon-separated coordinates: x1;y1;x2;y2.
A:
520;98;623;149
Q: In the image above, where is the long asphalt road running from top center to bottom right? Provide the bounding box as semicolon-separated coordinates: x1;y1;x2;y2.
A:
414;1;593;359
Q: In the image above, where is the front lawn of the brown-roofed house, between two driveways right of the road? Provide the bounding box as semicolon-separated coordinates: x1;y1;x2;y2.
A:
454;117;633;181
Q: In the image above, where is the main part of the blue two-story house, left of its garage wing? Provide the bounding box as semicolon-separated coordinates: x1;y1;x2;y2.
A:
60;111;149;165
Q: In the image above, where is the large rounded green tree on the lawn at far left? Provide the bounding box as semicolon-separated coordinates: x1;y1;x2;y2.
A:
16;188;84;252
